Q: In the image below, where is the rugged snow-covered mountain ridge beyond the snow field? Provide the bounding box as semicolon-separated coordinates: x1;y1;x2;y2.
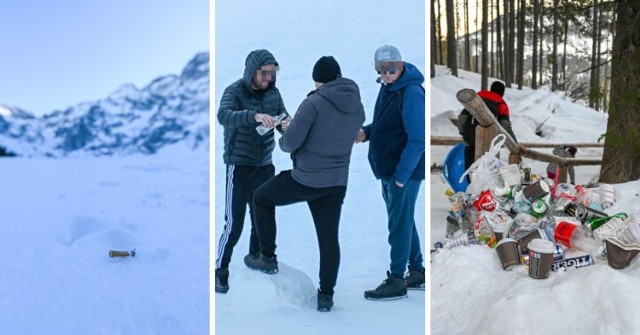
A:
0;52;209;157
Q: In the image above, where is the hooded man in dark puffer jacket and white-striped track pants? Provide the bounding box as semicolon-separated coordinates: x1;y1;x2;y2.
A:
215;50;291;293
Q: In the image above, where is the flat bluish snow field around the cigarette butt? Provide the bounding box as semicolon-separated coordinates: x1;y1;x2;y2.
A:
0;144;210;334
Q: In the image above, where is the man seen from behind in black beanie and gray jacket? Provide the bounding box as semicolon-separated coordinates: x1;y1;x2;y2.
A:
247;56;365;312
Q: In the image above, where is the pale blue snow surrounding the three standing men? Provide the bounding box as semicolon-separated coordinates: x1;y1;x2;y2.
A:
212;0;426;335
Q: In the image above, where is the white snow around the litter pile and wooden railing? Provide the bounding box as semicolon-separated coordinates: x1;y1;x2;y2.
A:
429;67;640;334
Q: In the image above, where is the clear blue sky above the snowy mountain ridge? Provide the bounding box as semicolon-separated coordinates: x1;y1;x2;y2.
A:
0;0;209;115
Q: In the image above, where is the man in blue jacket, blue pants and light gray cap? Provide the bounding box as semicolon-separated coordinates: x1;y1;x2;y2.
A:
356;45;425;300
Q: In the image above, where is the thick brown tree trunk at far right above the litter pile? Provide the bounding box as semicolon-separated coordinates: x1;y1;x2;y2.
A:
600;0;640;184
